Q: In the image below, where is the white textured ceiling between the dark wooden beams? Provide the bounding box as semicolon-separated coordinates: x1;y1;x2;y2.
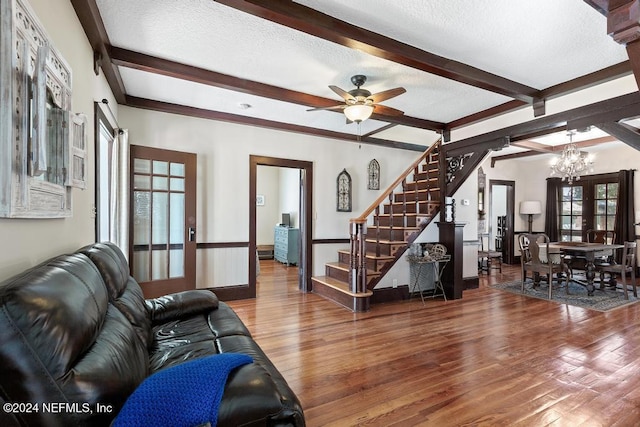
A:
96;0;628;150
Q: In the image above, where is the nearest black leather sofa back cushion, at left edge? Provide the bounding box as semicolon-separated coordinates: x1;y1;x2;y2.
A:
0;254;148;425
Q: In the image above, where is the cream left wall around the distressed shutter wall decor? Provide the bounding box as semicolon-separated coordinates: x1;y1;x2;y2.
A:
0;0;117;280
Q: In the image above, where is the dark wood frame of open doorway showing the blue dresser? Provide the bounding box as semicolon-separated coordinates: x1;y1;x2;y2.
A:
249;155;313;298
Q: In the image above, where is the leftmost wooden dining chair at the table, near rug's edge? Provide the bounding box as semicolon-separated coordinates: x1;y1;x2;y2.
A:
518;233;570;299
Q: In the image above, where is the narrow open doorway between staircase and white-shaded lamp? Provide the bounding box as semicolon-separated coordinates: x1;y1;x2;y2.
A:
488;179;516;264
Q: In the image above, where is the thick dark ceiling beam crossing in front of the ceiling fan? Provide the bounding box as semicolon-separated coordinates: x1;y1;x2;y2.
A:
216;0;541;104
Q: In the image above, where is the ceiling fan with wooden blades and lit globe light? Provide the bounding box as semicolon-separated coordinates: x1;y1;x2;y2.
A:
307;74;406;123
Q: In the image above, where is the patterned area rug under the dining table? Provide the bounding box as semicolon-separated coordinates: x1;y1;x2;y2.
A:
491;280;638;311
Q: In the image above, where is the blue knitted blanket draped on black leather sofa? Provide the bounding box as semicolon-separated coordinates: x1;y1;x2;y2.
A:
112;353;253;427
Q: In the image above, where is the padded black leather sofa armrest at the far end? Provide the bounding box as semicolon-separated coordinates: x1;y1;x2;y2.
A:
145;289;218;323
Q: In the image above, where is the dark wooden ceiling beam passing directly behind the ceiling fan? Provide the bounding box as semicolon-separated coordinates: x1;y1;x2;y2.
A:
109;46;445;132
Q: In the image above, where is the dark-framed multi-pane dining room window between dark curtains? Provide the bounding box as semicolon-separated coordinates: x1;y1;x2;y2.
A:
558;174;618;242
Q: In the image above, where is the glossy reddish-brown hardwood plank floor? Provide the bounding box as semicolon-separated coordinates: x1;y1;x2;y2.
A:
229;261;640;427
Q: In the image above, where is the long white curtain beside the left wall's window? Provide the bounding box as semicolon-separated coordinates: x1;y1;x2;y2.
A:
109;129;130;257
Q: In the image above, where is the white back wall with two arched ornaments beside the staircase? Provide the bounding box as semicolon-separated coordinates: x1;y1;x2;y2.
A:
119;106;424;287
